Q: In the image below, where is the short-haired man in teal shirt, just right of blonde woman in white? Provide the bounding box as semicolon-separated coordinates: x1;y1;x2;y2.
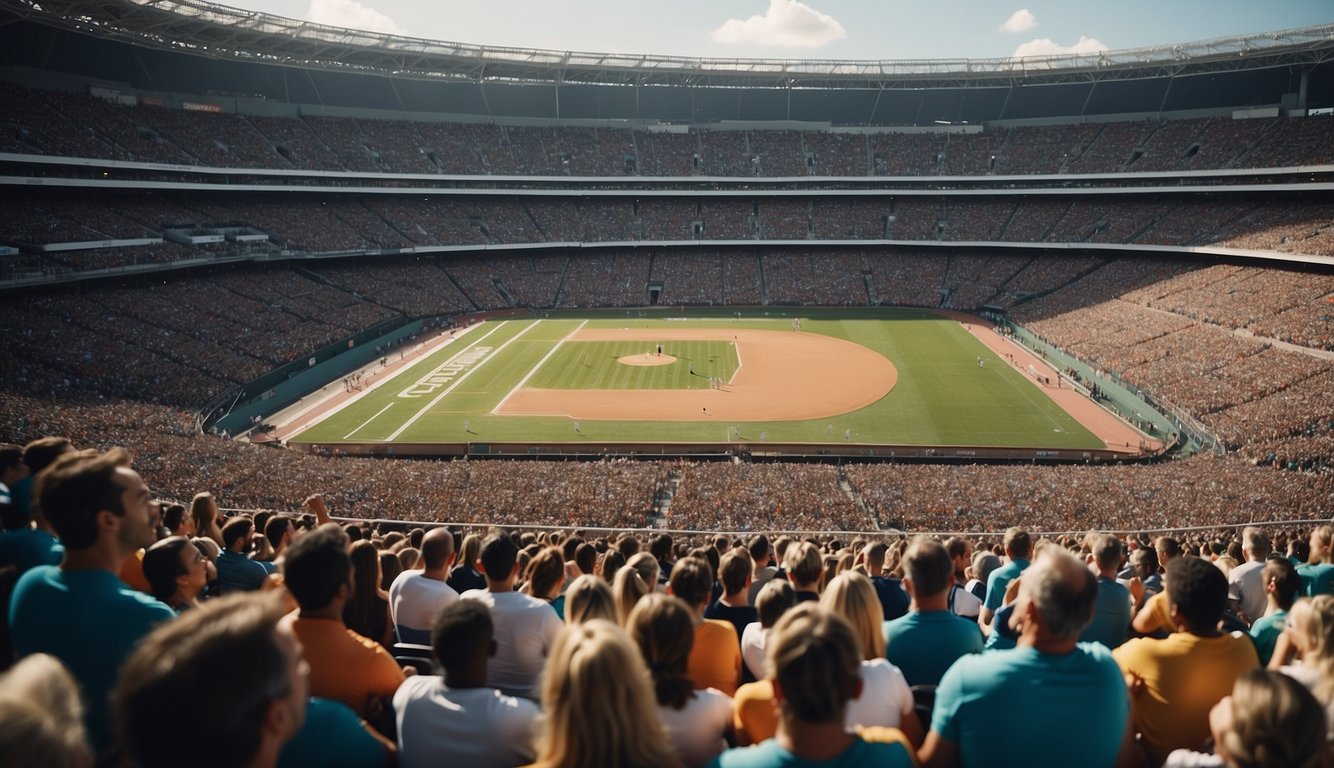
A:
884;536;982;685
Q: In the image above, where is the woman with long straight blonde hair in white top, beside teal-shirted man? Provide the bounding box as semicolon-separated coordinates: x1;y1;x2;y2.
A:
820;571;924;745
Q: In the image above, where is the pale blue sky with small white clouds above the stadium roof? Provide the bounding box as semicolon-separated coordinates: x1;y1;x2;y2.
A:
215;0;1334;59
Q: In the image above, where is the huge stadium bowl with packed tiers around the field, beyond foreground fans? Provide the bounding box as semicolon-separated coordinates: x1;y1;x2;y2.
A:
0;1;1334;531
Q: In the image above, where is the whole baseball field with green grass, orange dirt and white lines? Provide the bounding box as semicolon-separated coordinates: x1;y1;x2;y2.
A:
284;308;1129;451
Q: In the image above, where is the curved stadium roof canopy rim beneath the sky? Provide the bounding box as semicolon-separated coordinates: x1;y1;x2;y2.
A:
0;0;1334;89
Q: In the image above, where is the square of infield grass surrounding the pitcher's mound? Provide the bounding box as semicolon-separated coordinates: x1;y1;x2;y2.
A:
528;341;736;389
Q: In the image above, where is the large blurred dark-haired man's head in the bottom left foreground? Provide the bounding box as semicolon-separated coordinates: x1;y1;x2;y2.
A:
116;595;308;768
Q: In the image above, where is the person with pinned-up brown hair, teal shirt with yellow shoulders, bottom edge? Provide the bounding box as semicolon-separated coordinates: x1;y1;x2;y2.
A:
711;605;914;768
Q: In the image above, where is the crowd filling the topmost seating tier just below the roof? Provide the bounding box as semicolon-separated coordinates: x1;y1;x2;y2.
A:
0;84;1334;177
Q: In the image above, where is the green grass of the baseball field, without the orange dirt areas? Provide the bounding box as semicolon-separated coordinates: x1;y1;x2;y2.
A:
292;309;1103;449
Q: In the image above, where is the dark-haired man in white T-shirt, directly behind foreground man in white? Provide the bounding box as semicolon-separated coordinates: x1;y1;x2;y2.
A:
460;533;560;699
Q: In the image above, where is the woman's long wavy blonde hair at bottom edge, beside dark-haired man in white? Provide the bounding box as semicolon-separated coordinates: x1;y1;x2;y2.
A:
534;619;682;768
